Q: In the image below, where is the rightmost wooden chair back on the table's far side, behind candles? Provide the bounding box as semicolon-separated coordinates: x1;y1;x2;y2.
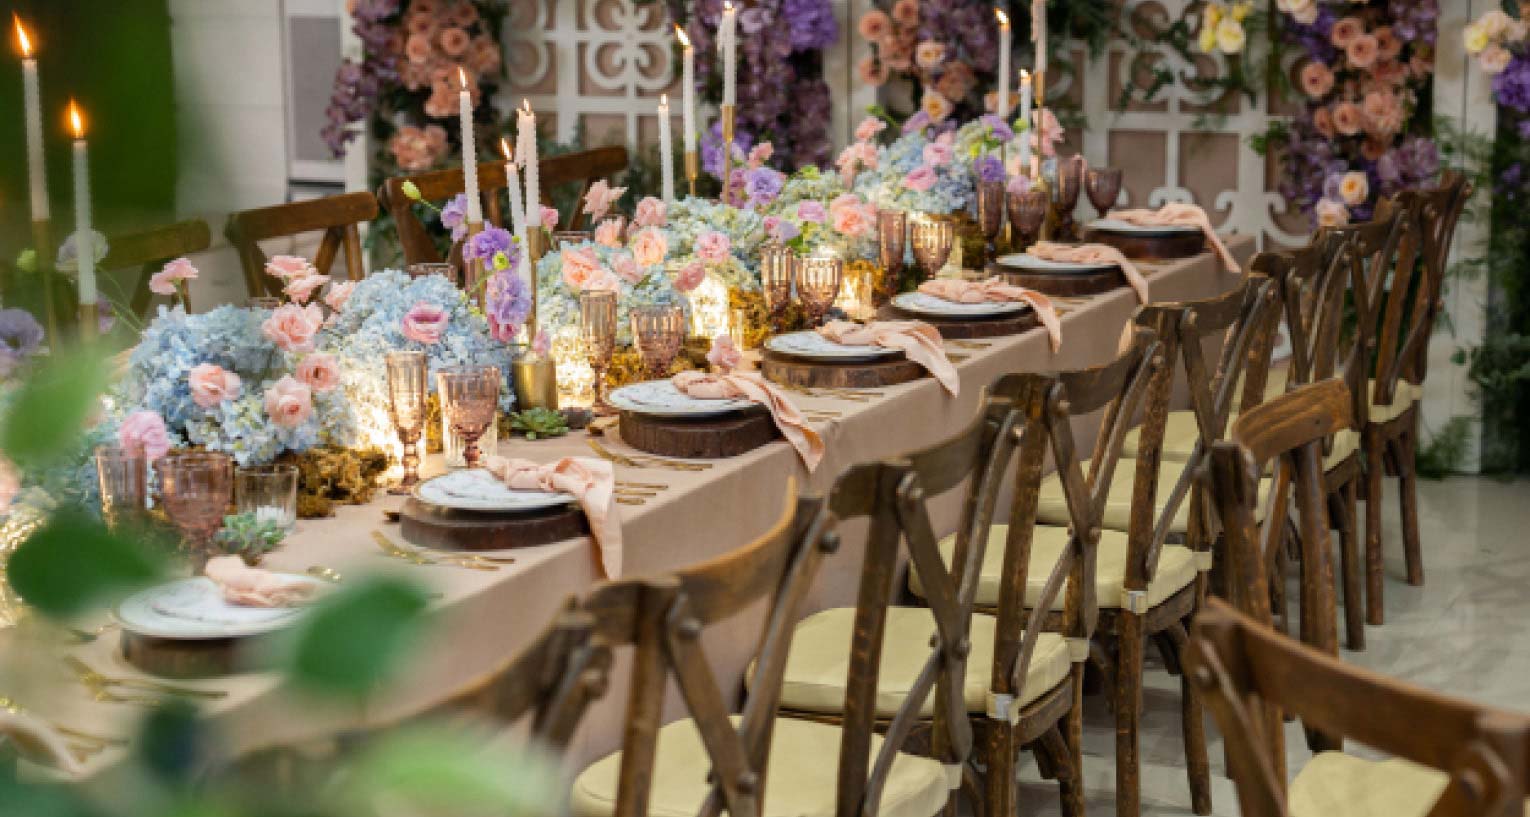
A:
385;145;627;263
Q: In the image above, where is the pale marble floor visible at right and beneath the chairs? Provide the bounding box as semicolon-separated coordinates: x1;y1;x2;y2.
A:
1019;477;1530;817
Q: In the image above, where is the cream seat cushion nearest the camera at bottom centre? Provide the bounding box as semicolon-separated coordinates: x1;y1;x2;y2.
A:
569;718;949;817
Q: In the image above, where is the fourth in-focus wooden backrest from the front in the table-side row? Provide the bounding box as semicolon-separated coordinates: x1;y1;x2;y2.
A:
1126;274;1278;592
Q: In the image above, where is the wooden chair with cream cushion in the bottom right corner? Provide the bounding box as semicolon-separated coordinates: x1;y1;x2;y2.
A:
1189;600;1530;817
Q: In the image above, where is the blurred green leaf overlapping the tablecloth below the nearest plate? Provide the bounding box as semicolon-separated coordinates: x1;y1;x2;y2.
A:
285;577;427;699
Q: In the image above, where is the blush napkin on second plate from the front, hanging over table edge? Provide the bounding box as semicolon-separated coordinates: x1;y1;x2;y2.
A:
483;456;621;578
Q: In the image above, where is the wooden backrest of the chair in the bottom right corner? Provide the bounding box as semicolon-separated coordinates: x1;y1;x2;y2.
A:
1186;598;1530;817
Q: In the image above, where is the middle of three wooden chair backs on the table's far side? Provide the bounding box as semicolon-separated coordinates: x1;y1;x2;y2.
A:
223;191;378;298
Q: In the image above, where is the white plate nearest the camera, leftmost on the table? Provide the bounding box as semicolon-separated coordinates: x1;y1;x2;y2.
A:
112;575;327;641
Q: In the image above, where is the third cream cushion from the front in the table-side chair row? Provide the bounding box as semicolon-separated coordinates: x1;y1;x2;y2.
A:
909;525;1195;610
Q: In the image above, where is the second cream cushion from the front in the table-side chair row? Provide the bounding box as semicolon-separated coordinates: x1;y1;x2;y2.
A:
750;607;1071;718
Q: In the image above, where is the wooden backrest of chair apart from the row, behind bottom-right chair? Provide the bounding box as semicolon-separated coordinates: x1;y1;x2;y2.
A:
1200;379;1354;779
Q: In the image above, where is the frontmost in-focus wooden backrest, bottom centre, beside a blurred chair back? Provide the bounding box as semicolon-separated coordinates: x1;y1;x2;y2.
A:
580;488;832;817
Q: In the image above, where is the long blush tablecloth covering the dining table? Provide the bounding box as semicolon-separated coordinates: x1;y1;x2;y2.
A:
0;236;1253;783
